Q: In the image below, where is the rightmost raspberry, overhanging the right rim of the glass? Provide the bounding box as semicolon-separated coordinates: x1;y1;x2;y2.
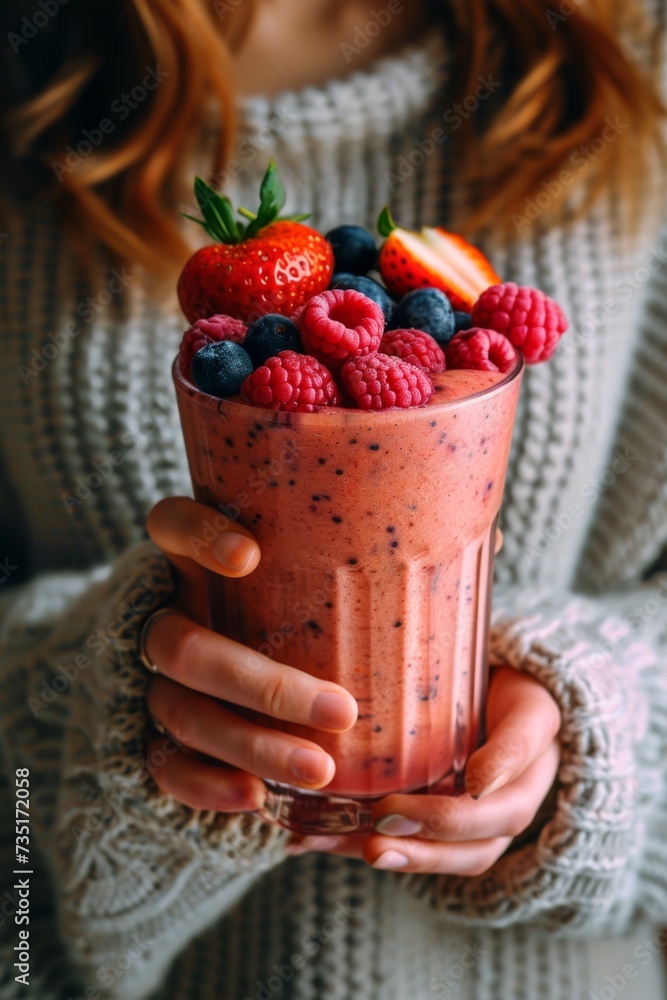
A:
472;281;568;365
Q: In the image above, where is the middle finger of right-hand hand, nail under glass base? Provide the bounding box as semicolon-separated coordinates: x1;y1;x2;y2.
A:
373;741;560;843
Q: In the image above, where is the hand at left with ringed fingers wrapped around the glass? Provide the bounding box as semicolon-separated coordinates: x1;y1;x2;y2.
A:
145;497;357;812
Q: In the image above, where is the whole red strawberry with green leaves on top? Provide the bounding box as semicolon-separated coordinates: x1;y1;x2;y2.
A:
178;160;334;323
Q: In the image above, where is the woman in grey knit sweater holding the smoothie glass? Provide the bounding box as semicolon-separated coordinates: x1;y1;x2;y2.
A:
1;0;667;1000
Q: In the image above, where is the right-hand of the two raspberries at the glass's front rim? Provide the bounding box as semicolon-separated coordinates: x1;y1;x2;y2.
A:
340;354;433;410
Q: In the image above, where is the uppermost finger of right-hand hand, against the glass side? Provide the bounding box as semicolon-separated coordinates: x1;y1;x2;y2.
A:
466;667;561;799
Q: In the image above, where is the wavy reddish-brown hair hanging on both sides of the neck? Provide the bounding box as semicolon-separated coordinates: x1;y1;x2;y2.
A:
2;0;664;274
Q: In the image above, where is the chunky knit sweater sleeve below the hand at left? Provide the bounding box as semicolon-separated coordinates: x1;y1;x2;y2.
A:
0;543;287;1000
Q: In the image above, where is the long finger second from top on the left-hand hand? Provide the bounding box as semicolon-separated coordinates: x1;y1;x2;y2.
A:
145;614;358;732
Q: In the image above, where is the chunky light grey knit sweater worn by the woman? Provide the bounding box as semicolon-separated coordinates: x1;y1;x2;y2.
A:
0;19;667;1000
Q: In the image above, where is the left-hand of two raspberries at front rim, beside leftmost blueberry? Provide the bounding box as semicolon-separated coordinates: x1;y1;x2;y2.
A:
241;351;340;413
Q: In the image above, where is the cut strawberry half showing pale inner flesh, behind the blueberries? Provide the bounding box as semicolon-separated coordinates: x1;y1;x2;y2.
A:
378;208;500;313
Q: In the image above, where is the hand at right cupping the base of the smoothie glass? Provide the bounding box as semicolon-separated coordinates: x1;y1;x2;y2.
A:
289;667;561;876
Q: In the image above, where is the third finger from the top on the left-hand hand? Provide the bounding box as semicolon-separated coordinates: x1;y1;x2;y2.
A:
147;677;335;788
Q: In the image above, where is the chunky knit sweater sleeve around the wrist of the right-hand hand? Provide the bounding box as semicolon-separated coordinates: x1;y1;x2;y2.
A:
399;578;667;937
